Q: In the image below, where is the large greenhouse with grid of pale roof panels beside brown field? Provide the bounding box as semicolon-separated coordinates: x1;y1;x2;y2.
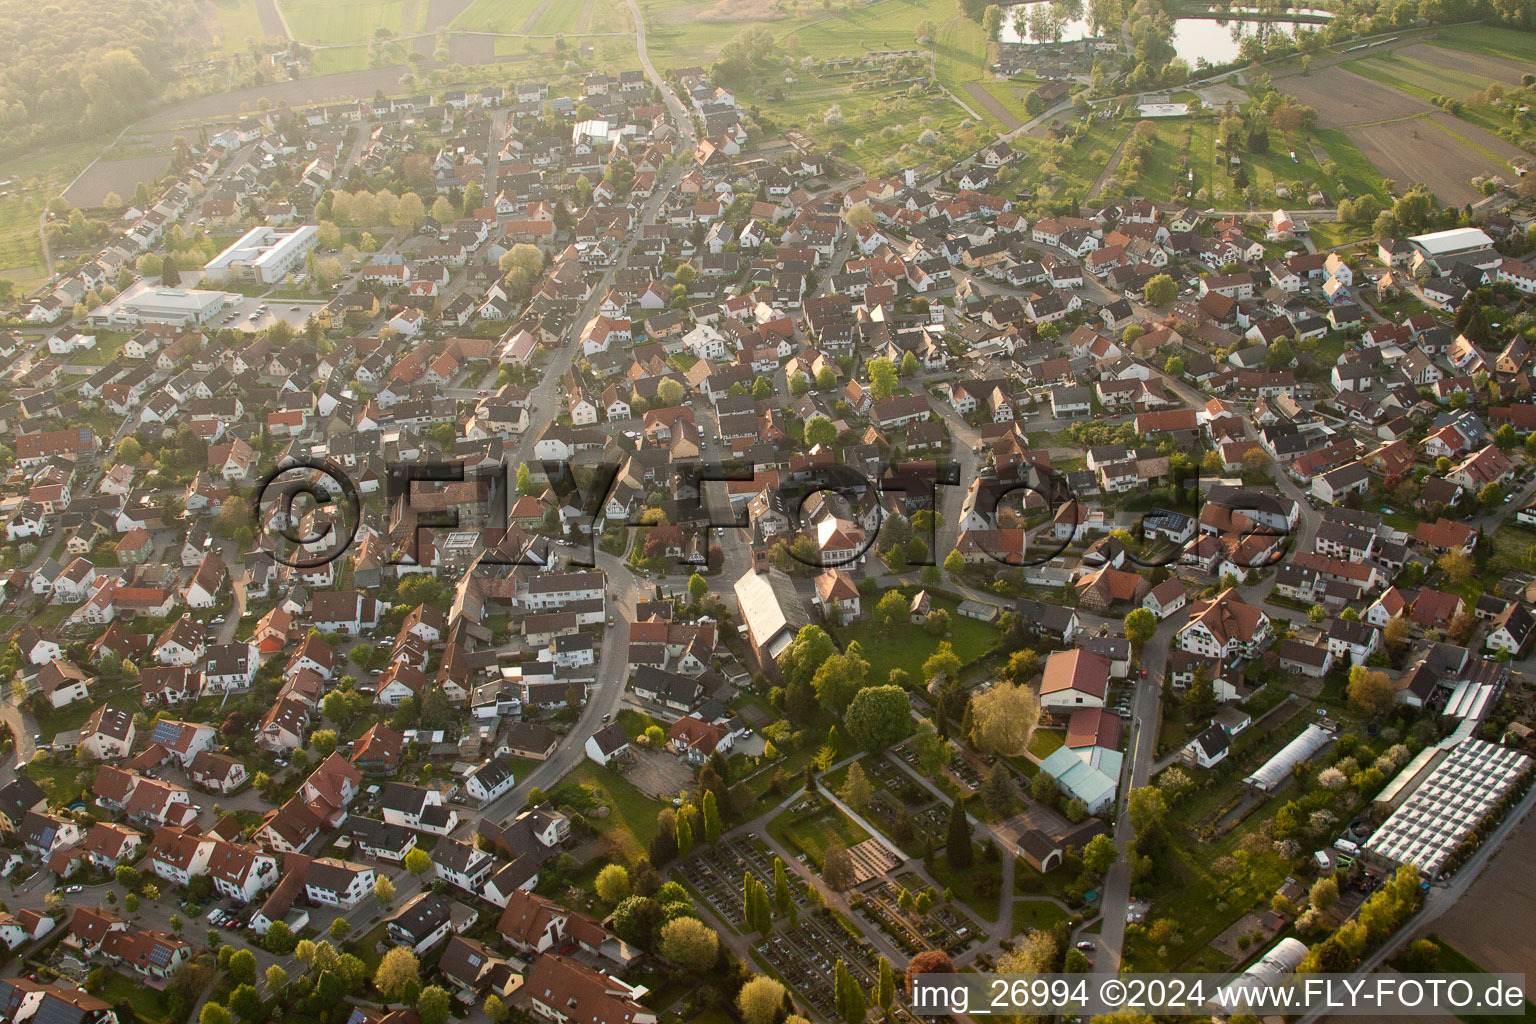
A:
1366;738;1531;878
